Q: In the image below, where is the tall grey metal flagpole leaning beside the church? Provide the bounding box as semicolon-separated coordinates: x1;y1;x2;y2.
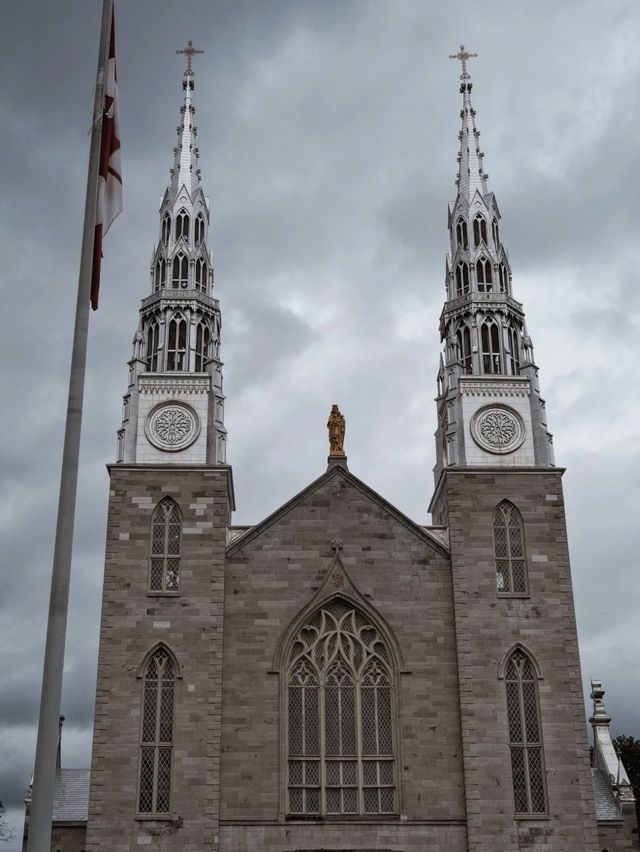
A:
27;0;113;852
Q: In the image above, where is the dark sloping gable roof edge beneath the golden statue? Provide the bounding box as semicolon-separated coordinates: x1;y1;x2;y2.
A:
227;459;449;558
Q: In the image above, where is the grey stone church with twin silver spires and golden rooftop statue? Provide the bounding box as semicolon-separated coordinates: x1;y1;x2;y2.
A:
22;45;638;852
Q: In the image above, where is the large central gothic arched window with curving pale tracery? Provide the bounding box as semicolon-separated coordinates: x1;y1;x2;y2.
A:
287;598;398;815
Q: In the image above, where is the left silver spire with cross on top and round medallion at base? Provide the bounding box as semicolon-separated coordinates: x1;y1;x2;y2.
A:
117;42;227;464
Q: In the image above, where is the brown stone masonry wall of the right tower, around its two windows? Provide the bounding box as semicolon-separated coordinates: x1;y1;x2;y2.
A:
434;469;599;852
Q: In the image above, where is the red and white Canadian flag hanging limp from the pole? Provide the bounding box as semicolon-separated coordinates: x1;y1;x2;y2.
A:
91;12;122;311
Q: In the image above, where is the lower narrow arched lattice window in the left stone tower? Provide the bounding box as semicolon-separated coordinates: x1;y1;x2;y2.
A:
138;648;175;814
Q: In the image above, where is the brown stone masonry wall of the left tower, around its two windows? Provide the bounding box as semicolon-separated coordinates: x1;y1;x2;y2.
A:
86;465;230;852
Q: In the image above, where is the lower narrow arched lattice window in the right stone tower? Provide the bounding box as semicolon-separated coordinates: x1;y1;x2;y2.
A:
505;650;547;814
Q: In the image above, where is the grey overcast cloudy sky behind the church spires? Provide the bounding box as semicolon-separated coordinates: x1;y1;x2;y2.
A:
0;0;640;849
